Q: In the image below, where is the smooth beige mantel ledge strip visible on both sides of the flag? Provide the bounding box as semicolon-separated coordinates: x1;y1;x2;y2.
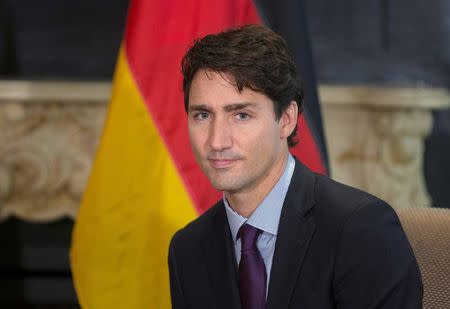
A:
0;81;450;109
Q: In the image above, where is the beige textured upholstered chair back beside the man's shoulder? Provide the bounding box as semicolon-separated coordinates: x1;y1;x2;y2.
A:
396;208;450;309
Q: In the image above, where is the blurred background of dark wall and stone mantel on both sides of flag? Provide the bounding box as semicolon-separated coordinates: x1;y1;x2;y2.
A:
0;0;450;308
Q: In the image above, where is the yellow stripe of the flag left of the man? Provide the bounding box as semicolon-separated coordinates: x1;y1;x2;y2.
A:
71;50;197;309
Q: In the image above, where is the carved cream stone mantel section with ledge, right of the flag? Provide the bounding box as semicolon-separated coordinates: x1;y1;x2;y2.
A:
321;86;450;208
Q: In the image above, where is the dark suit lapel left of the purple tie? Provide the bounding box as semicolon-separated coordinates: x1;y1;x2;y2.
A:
204;202;241;309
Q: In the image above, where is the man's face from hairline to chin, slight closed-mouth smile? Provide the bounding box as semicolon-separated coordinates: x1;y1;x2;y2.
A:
188;70;292;193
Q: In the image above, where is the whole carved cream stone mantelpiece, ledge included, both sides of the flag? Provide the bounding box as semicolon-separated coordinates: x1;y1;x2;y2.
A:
0;81;450;222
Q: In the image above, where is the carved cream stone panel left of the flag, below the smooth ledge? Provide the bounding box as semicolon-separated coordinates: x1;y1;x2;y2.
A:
0;84;106;222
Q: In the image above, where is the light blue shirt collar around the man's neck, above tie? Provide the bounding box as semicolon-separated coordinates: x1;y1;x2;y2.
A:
223;154;295;241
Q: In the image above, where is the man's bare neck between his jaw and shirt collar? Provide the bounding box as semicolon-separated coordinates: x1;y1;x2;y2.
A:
225;152;288;218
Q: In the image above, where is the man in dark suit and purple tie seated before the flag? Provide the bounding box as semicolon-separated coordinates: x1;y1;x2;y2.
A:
169;26;422;309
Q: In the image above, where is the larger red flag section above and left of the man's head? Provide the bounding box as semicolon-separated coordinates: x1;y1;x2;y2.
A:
125;0;260;213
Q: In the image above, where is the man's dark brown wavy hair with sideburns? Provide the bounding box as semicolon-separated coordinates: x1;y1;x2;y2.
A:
181;25;303;147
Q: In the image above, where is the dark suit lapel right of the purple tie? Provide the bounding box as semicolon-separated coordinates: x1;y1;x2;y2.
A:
266;161;315;309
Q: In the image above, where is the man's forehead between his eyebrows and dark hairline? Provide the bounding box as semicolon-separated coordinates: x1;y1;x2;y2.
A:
189;69;272;105
